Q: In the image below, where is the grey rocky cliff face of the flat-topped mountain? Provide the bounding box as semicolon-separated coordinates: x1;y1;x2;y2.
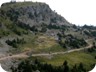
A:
1;2;71;26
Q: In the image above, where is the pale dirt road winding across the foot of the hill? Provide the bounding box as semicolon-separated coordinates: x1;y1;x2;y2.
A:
0;40;92;61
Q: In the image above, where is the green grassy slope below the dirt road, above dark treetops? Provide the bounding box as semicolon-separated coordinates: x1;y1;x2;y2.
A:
34;51;96;70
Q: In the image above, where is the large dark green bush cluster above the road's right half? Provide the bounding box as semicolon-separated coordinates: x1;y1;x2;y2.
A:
58;34;87;48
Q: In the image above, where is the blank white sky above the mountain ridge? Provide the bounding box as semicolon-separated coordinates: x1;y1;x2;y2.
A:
0;0;96;26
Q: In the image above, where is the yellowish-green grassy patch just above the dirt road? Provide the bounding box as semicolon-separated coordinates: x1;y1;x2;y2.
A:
13;34;66;53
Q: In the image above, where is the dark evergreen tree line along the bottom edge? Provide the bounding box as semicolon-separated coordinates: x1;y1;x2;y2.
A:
11;59;95;72
